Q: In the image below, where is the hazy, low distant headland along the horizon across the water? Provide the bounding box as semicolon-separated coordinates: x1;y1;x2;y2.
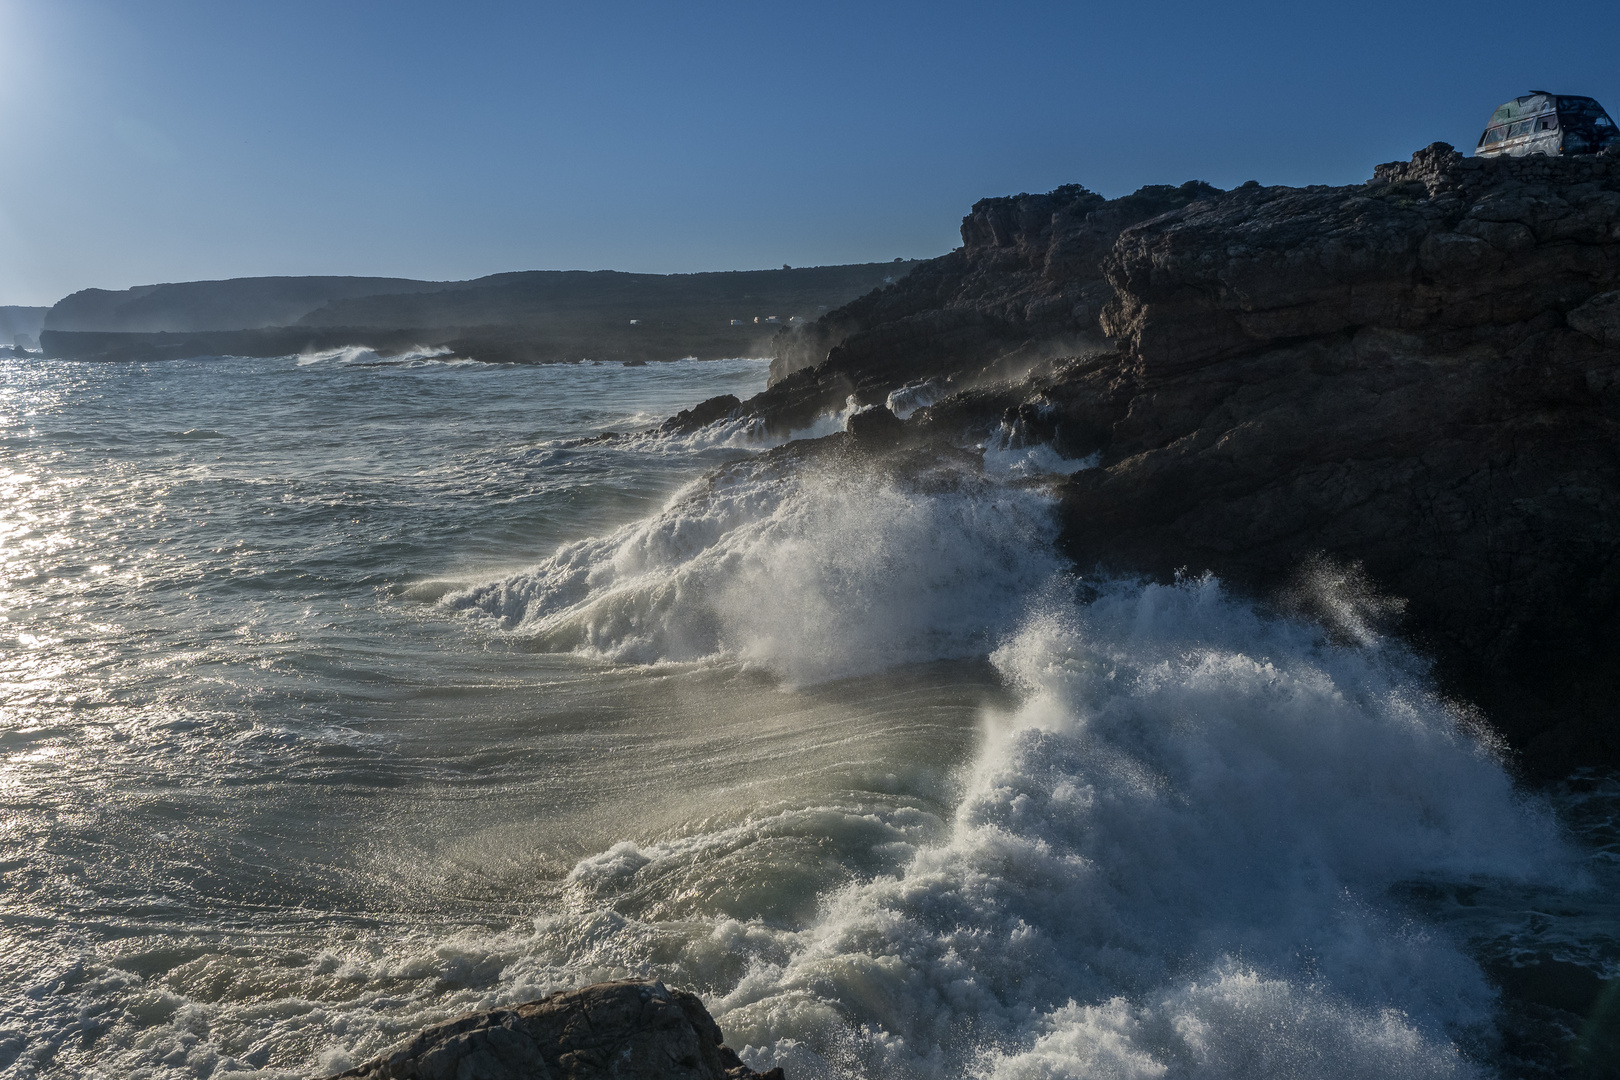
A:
41;261;914;363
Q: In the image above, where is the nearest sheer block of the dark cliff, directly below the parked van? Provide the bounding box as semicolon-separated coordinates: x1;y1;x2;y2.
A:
1064;146;1620;772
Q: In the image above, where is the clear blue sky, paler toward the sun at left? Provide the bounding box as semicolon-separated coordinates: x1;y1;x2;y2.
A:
0;0;1620;304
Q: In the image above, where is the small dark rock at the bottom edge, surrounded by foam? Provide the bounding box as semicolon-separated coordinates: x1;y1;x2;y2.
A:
334;981;782;1080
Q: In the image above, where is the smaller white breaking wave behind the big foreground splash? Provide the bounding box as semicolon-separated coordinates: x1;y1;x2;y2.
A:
444;463;1059;683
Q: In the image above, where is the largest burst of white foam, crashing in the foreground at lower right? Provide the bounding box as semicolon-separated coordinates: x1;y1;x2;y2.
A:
706;580;1570;1080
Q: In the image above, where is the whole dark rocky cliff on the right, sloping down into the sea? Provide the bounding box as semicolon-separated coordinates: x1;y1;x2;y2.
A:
716;144;1620;774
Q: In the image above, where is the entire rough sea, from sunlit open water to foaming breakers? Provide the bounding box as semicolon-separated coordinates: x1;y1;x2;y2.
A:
0;350;1620;1080
